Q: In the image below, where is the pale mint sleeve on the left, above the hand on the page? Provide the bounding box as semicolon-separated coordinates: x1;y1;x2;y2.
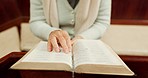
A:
30;0;58;40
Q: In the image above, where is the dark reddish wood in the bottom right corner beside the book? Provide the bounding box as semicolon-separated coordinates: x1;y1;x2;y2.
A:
120;55;148;78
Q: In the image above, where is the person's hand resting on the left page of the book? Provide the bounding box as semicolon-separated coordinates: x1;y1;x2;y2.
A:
47;30;71;53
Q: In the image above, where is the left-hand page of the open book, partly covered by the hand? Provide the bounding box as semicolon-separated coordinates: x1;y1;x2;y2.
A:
22;41;72;68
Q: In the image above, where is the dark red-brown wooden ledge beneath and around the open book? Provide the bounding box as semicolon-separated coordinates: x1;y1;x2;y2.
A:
0;52;148;78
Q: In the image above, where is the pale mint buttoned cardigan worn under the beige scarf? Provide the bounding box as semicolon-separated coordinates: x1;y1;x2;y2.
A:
30;0;111;40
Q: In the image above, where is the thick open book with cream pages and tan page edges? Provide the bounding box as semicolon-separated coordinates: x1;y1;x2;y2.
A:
11;39;134;76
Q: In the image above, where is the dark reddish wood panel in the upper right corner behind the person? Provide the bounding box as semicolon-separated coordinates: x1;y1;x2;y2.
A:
112;0;148;20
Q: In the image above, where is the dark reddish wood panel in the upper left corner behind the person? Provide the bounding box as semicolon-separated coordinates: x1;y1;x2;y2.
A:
0;0;30;31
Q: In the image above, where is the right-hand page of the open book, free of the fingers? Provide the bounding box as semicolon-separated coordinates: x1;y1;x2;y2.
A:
73;40;122;68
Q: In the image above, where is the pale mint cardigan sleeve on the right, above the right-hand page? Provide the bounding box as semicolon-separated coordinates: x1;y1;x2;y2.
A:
78;0;111;39
